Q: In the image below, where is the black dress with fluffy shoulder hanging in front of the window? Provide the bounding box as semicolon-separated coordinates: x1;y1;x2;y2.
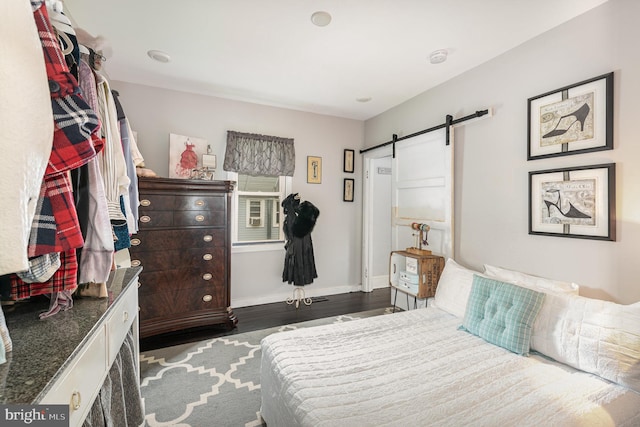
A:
282;193;320;286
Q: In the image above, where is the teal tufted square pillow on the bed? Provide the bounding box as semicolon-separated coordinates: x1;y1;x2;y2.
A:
459;274;545;356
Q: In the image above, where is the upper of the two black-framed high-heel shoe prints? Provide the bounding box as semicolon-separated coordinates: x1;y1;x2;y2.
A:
527;73;613;160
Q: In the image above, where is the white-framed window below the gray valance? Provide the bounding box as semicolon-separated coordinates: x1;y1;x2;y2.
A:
230;174;292;246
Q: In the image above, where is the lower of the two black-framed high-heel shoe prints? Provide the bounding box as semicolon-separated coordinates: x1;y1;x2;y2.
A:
529;163;616;241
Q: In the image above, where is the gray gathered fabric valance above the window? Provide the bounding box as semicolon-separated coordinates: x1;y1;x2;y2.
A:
223;130;296;176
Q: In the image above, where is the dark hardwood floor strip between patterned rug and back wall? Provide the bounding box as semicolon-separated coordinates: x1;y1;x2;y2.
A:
140;288;391;352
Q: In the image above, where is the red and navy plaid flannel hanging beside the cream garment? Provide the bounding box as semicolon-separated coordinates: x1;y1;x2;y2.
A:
10;0;101;317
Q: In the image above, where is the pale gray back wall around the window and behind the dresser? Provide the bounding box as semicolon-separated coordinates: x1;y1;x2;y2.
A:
111;81;364;307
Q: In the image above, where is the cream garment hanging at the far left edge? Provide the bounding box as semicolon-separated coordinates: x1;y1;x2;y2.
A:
0;0;53;274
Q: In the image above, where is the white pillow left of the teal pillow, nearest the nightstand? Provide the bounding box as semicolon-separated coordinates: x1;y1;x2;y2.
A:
433;258;480;318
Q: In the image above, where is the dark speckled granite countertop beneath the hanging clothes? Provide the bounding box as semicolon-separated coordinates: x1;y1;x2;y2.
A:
0;267;142;404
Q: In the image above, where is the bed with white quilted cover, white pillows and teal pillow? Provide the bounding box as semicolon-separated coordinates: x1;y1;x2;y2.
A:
261;260;640;427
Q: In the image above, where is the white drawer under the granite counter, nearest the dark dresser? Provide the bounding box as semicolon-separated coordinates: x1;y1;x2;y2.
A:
107;283;138;366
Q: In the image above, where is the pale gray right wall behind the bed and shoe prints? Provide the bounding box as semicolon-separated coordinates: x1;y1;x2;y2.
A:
365;0;640;303
